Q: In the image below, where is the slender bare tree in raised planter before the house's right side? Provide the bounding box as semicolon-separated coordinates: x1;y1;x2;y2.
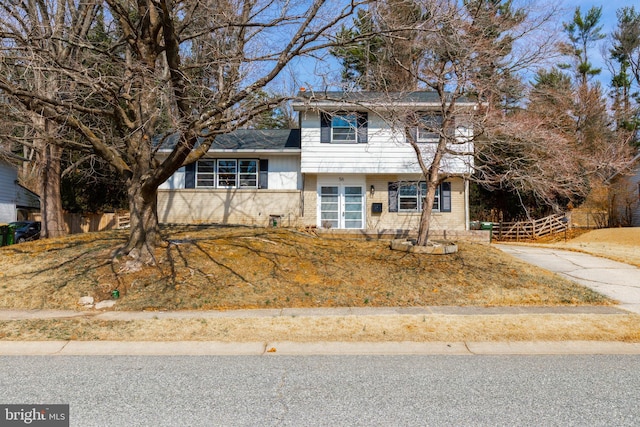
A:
405;0;553;245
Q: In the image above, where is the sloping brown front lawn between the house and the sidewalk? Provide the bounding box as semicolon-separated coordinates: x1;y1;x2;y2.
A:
0;226;610;310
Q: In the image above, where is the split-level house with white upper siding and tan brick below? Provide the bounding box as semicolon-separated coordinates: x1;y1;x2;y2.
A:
158;92;473;233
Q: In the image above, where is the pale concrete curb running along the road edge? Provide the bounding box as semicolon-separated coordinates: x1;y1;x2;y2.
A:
0;341;640;356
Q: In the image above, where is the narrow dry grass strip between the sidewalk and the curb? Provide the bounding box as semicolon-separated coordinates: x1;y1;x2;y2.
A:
0;314;640;342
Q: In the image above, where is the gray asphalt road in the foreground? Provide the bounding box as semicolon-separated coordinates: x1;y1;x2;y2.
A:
0;355;640;427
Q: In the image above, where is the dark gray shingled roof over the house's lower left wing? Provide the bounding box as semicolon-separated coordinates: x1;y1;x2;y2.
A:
160;129;300;151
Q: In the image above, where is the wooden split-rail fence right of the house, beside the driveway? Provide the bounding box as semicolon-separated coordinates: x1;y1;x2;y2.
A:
493;214;569;241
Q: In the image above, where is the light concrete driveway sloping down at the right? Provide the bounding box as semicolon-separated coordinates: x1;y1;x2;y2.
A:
494;244;640;314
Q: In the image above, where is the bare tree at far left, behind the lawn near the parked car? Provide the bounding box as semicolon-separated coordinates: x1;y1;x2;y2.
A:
0;1;93;237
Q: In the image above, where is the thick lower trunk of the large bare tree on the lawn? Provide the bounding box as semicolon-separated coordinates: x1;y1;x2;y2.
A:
124;178;162;263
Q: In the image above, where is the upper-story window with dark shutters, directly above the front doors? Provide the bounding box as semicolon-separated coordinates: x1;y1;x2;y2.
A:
320;112;368;144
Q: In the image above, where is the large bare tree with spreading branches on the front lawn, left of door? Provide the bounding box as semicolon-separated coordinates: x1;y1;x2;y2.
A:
0;0;359;260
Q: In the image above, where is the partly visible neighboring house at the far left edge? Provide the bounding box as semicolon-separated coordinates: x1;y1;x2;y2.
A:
0;157;40;224
